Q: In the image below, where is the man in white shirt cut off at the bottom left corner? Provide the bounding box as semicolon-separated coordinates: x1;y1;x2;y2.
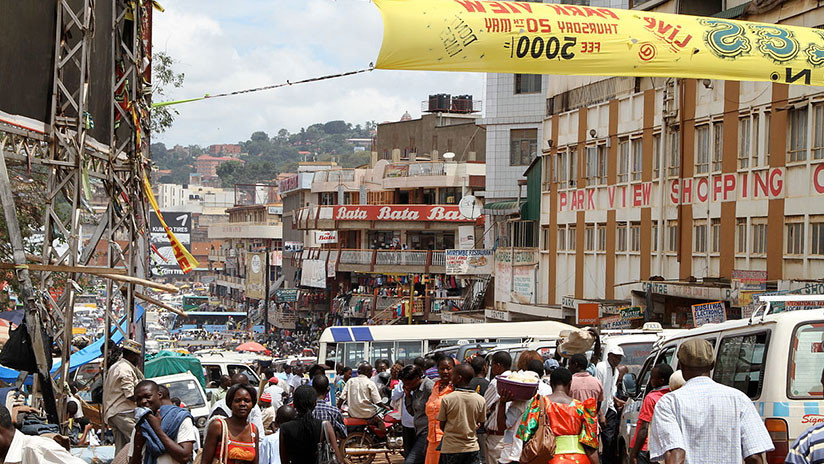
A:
0;404;85;464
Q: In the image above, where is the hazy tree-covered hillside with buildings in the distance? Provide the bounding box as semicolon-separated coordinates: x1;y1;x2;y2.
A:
151;121;376;187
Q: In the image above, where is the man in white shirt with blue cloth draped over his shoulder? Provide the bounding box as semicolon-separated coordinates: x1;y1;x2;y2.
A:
128;380;198;464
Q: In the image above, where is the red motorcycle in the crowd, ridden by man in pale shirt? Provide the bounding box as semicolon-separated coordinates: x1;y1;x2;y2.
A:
340;407;403;464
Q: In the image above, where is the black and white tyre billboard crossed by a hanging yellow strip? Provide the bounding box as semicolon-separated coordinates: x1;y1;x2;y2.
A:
149;211;192;275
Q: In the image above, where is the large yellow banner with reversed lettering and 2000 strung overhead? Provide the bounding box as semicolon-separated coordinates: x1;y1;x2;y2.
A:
374;0;824;85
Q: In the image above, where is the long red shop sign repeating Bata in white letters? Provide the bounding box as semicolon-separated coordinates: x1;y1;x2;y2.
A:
332;205;475;222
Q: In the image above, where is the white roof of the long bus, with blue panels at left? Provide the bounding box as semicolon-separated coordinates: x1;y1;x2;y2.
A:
320;321;575;343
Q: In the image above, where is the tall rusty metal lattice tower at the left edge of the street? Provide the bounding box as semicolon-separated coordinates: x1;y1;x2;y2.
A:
0;0;153;422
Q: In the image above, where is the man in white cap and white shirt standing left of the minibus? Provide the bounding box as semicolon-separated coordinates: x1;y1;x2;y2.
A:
595;345;624;464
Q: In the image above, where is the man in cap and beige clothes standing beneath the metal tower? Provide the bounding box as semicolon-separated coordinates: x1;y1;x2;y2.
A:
103;340;143;455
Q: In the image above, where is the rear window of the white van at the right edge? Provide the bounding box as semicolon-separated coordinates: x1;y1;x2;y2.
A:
787;322;824;400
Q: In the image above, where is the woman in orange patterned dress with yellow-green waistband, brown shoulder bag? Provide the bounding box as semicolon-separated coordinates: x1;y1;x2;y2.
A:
517;367;598;464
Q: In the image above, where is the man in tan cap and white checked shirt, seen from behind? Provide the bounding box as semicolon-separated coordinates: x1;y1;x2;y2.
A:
649;338;774;464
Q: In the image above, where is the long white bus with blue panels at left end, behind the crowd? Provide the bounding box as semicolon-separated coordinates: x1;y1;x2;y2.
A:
318;321;575;367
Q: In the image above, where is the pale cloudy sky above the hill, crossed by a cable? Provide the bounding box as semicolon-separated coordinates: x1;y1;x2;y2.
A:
153;0;485;146
